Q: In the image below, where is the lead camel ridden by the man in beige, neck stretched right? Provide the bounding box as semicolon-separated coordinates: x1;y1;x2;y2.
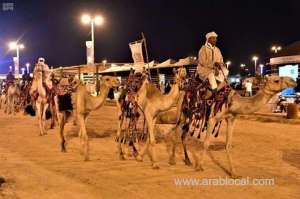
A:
170;76;297;177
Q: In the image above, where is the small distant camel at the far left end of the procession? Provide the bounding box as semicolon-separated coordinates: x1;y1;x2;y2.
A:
5;83;21;115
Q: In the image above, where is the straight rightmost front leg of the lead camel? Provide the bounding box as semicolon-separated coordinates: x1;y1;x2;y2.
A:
226;117;236;177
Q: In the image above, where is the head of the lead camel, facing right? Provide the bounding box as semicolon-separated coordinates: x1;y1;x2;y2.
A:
264;75;297;94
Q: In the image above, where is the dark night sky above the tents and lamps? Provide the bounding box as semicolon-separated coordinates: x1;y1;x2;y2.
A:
0;0;300;73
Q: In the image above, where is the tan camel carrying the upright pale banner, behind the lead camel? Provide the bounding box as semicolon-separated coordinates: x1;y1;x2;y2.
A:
117;68;186;169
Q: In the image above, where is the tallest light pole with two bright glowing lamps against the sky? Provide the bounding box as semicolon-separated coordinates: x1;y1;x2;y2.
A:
81;14;104;64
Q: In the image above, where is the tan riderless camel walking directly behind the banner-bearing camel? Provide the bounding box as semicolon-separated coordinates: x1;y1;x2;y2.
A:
56;76;120;161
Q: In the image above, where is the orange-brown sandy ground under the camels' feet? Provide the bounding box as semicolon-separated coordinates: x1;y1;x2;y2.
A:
0;106;300;199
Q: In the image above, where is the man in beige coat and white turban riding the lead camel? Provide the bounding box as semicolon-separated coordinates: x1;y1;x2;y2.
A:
197;32;229;94
